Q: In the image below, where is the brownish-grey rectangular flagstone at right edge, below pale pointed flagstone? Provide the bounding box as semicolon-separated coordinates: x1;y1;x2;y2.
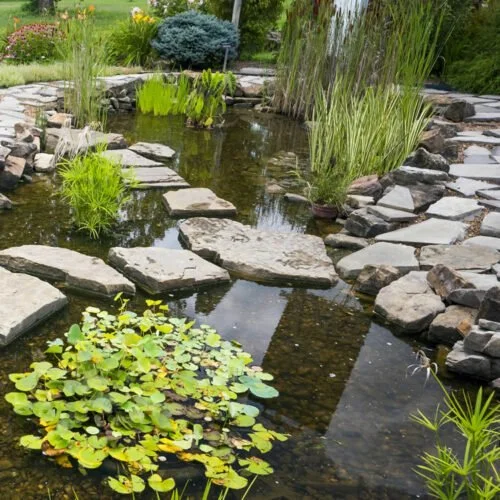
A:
419;244;500;272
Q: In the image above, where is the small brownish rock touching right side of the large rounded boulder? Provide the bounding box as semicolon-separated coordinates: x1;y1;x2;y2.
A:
427;306;477;345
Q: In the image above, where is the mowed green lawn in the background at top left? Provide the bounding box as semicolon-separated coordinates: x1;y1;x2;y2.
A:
0;0;147;31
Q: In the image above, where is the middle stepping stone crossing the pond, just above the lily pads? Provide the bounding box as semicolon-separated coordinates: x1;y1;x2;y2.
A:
108;247;230;295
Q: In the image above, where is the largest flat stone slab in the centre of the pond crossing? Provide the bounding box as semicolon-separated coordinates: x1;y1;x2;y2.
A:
179;217;338;288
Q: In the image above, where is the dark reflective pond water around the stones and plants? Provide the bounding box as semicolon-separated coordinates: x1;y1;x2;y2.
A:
0;110;472;500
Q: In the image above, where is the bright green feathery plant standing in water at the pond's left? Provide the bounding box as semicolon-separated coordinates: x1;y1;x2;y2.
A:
59;146;130;238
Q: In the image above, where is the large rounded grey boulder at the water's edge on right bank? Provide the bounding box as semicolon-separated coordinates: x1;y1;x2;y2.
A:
374;271;445;334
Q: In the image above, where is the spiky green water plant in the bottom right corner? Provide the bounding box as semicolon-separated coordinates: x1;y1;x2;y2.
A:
411;352;500;500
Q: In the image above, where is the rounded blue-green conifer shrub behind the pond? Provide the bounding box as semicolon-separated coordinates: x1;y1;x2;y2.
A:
152;11;239;68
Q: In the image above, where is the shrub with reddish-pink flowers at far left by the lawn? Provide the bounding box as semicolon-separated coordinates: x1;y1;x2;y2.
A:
4;23;62;64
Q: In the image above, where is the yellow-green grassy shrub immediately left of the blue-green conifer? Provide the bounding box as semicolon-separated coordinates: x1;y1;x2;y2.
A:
108;9;158;66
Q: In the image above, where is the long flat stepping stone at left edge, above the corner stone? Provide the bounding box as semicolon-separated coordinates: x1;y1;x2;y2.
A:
0;245;135;297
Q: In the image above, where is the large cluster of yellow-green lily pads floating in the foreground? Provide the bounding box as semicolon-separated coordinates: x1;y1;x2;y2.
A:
6;301;287;494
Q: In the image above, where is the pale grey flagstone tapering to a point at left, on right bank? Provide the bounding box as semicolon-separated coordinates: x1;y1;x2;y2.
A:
375;219;466;247
